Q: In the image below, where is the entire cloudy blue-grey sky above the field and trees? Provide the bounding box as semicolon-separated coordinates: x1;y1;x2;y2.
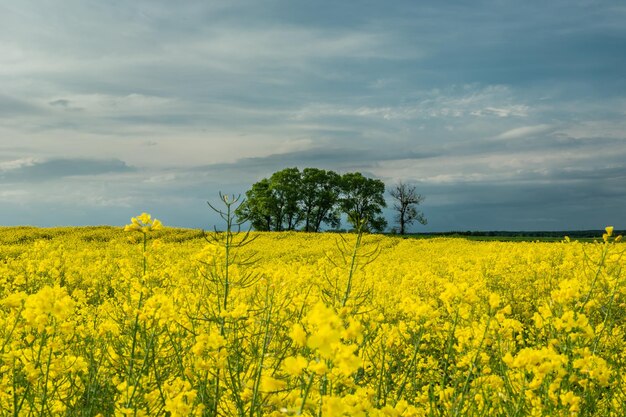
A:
0;0;626;232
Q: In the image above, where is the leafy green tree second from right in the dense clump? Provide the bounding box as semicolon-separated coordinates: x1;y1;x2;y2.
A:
300;168;341;232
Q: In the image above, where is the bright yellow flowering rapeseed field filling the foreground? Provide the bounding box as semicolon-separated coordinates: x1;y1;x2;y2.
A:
0;216;626;416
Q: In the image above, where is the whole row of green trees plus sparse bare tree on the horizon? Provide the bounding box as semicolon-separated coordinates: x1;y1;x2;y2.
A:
236;168;426;234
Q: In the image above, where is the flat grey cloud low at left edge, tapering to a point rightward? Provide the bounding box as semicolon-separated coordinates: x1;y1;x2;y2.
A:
0;158;134;183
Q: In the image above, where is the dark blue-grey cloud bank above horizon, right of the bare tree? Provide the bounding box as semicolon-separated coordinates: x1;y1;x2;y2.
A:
410;171;626;230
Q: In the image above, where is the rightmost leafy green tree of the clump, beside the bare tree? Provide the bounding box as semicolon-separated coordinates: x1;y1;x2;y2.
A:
339;172;387;232
